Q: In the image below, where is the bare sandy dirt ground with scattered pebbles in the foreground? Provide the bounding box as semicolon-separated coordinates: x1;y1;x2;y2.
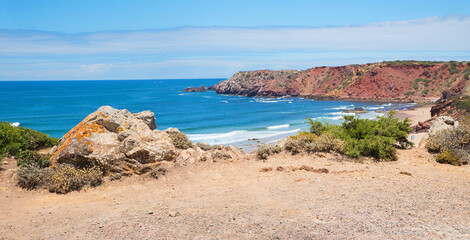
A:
0;149;470;239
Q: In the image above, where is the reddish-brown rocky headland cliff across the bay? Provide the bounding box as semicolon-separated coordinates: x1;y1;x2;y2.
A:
209;61;470;101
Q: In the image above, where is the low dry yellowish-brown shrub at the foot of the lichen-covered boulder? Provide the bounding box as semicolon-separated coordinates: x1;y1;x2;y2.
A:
49;164;103;194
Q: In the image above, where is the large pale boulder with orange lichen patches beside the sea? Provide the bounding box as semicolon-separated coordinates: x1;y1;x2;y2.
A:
51;106;177;174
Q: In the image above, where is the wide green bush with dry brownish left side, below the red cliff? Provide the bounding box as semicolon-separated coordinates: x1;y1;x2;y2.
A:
278;111;413;161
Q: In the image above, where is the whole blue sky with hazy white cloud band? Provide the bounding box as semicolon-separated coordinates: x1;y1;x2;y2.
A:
0;0;470;80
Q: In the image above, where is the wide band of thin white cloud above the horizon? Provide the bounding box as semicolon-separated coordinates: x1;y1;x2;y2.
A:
0;16;470;80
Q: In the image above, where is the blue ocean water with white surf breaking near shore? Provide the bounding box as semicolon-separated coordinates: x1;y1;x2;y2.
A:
0;79;410;148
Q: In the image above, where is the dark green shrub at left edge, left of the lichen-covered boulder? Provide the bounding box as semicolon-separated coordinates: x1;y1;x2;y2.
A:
0;122;59;156
